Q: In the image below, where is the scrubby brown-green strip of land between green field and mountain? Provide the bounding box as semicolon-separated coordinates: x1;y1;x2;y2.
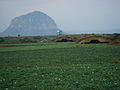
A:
0;34;120;45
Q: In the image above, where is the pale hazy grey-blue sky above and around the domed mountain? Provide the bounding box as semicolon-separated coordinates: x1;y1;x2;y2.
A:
0;0;120;34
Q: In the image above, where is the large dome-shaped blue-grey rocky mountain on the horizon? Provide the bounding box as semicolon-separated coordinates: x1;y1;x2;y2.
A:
0;11;59;36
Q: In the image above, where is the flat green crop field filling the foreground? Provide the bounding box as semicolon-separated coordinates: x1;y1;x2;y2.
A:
0;43;120;90
